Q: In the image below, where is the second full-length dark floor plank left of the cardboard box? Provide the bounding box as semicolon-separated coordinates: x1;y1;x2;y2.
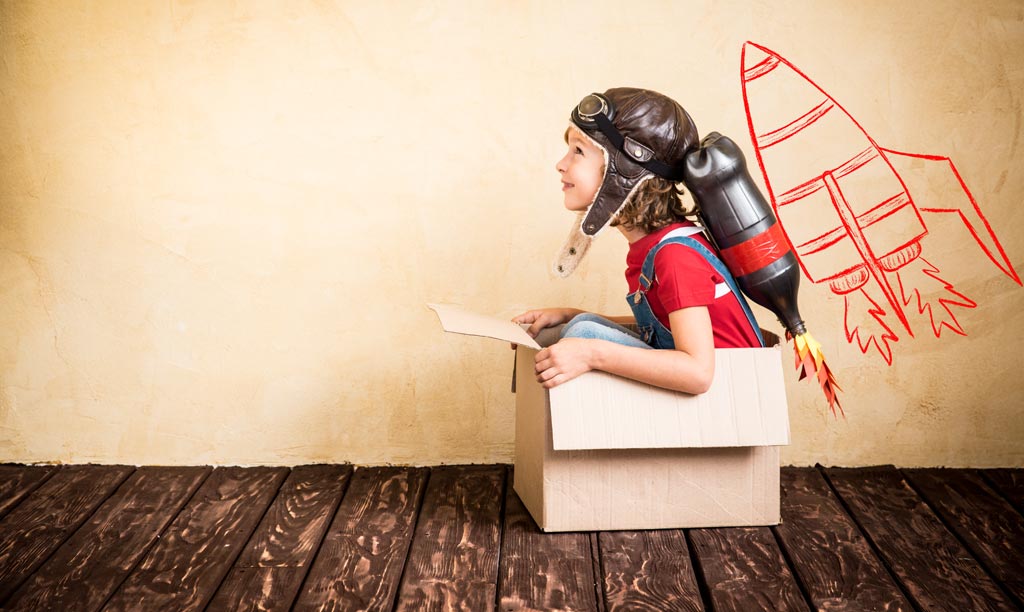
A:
294;468;430;612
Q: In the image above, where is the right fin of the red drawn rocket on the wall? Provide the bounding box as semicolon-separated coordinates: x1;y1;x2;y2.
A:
882;148;1024;285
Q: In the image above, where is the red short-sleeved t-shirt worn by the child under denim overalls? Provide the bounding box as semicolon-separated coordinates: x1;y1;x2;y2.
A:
626;221;761;349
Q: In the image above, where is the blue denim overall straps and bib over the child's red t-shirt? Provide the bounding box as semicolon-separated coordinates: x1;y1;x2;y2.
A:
626;226;765;349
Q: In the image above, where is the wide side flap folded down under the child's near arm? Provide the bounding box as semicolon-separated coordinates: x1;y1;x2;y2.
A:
550;348;790;450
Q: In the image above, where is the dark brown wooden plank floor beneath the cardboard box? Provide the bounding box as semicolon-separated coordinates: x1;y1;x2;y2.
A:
0;465;1024;612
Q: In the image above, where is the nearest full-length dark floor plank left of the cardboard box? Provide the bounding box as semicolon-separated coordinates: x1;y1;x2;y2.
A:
395;466;506;612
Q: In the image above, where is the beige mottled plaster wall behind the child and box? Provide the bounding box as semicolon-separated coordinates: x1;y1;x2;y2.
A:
0;0;1024;466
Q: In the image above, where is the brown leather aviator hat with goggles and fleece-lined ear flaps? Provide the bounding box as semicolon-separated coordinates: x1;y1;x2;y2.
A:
554;87;697;277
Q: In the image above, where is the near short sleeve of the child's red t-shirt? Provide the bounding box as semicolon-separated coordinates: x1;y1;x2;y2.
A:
654;245;725;312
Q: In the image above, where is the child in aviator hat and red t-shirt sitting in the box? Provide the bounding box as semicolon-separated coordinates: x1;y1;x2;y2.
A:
513;88;761;393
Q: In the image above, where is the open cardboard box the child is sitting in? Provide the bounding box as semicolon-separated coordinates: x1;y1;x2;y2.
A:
431;305;790;531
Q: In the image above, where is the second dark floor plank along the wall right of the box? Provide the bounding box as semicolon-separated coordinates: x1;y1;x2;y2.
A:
825;467;1016;610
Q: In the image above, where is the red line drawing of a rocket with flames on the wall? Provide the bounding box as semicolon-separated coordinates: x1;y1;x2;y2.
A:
741;42;1021;364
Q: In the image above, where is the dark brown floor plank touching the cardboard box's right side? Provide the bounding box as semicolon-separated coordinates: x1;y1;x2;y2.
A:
775;468;913;610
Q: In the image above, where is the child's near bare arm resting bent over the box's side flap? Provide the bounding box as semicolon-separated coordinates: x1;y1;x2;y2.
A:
536;306;715;394
